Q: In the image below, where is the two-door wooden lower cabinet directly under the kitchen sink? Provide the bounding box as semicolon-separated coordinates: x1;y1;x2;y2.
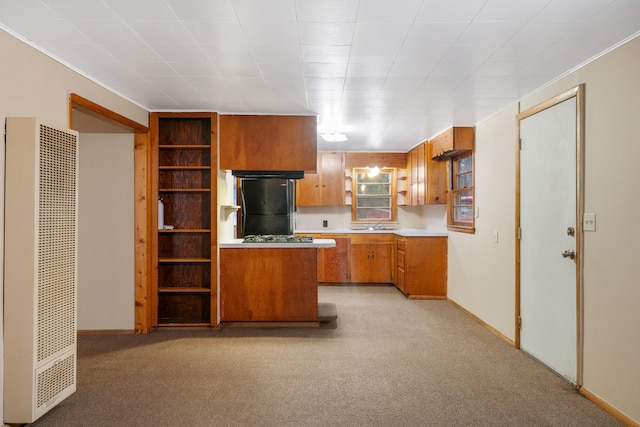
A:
350;233;394;283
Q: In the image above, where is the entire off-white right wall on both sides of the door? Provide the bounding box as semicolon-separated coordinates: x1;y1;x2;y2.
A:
449;38;640;423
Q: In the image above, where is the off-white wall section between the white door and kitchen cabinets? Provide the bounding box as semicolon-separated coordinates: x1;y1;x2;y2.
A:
448;105;518;340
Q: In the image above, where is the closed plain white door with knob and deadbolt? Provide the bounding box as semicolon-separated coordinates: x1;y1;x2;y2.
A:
519;96;580;384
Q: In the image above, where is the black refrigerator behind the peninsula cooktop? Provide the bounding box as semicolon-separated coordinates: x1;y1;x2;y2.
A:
241;178;295;237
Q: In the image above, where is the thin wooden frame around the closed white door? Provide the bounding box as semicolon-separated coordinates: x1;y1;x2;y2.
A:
515;83;585;388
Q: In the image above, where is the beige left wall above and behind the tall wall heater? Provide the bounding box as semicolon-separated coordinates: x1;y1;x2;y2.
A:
0;30;148;419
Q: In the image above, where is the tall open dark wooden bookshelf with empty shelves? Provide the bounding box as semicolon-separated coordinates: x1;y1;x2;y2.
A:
150;113;218;326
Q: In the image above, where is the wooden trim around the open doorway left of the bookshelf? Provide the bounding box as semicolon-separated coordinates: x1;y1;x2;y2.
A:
69;93;152;334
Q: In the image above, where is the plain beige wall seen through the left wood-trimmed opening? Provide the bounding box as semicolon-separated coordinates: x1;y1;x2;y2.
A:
78;133;135;331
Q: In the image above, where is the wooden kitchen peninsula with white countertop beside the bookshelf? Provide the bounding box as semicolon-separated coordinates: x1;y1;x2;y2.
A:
220;239;335;322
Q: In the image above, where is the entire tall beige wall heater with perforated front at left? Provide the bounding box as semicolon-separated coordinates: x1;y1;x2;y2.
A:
2;117;78;424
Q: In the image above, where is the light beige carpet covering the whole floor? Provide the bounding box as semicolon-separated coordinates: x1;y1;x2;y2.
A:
28;286;620;427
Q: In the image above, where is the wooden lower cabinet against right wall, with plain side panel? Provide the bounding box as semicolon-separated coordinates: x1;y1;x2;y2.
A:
396;237;447;299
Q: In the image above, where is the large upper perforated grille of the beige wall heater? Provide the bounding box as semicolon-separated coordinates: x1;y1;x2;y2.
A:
37;124;77;362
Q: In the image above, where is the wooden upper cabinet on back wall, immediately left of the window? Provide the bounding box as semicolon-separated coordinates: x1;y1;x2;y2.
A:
296;151;345;206
